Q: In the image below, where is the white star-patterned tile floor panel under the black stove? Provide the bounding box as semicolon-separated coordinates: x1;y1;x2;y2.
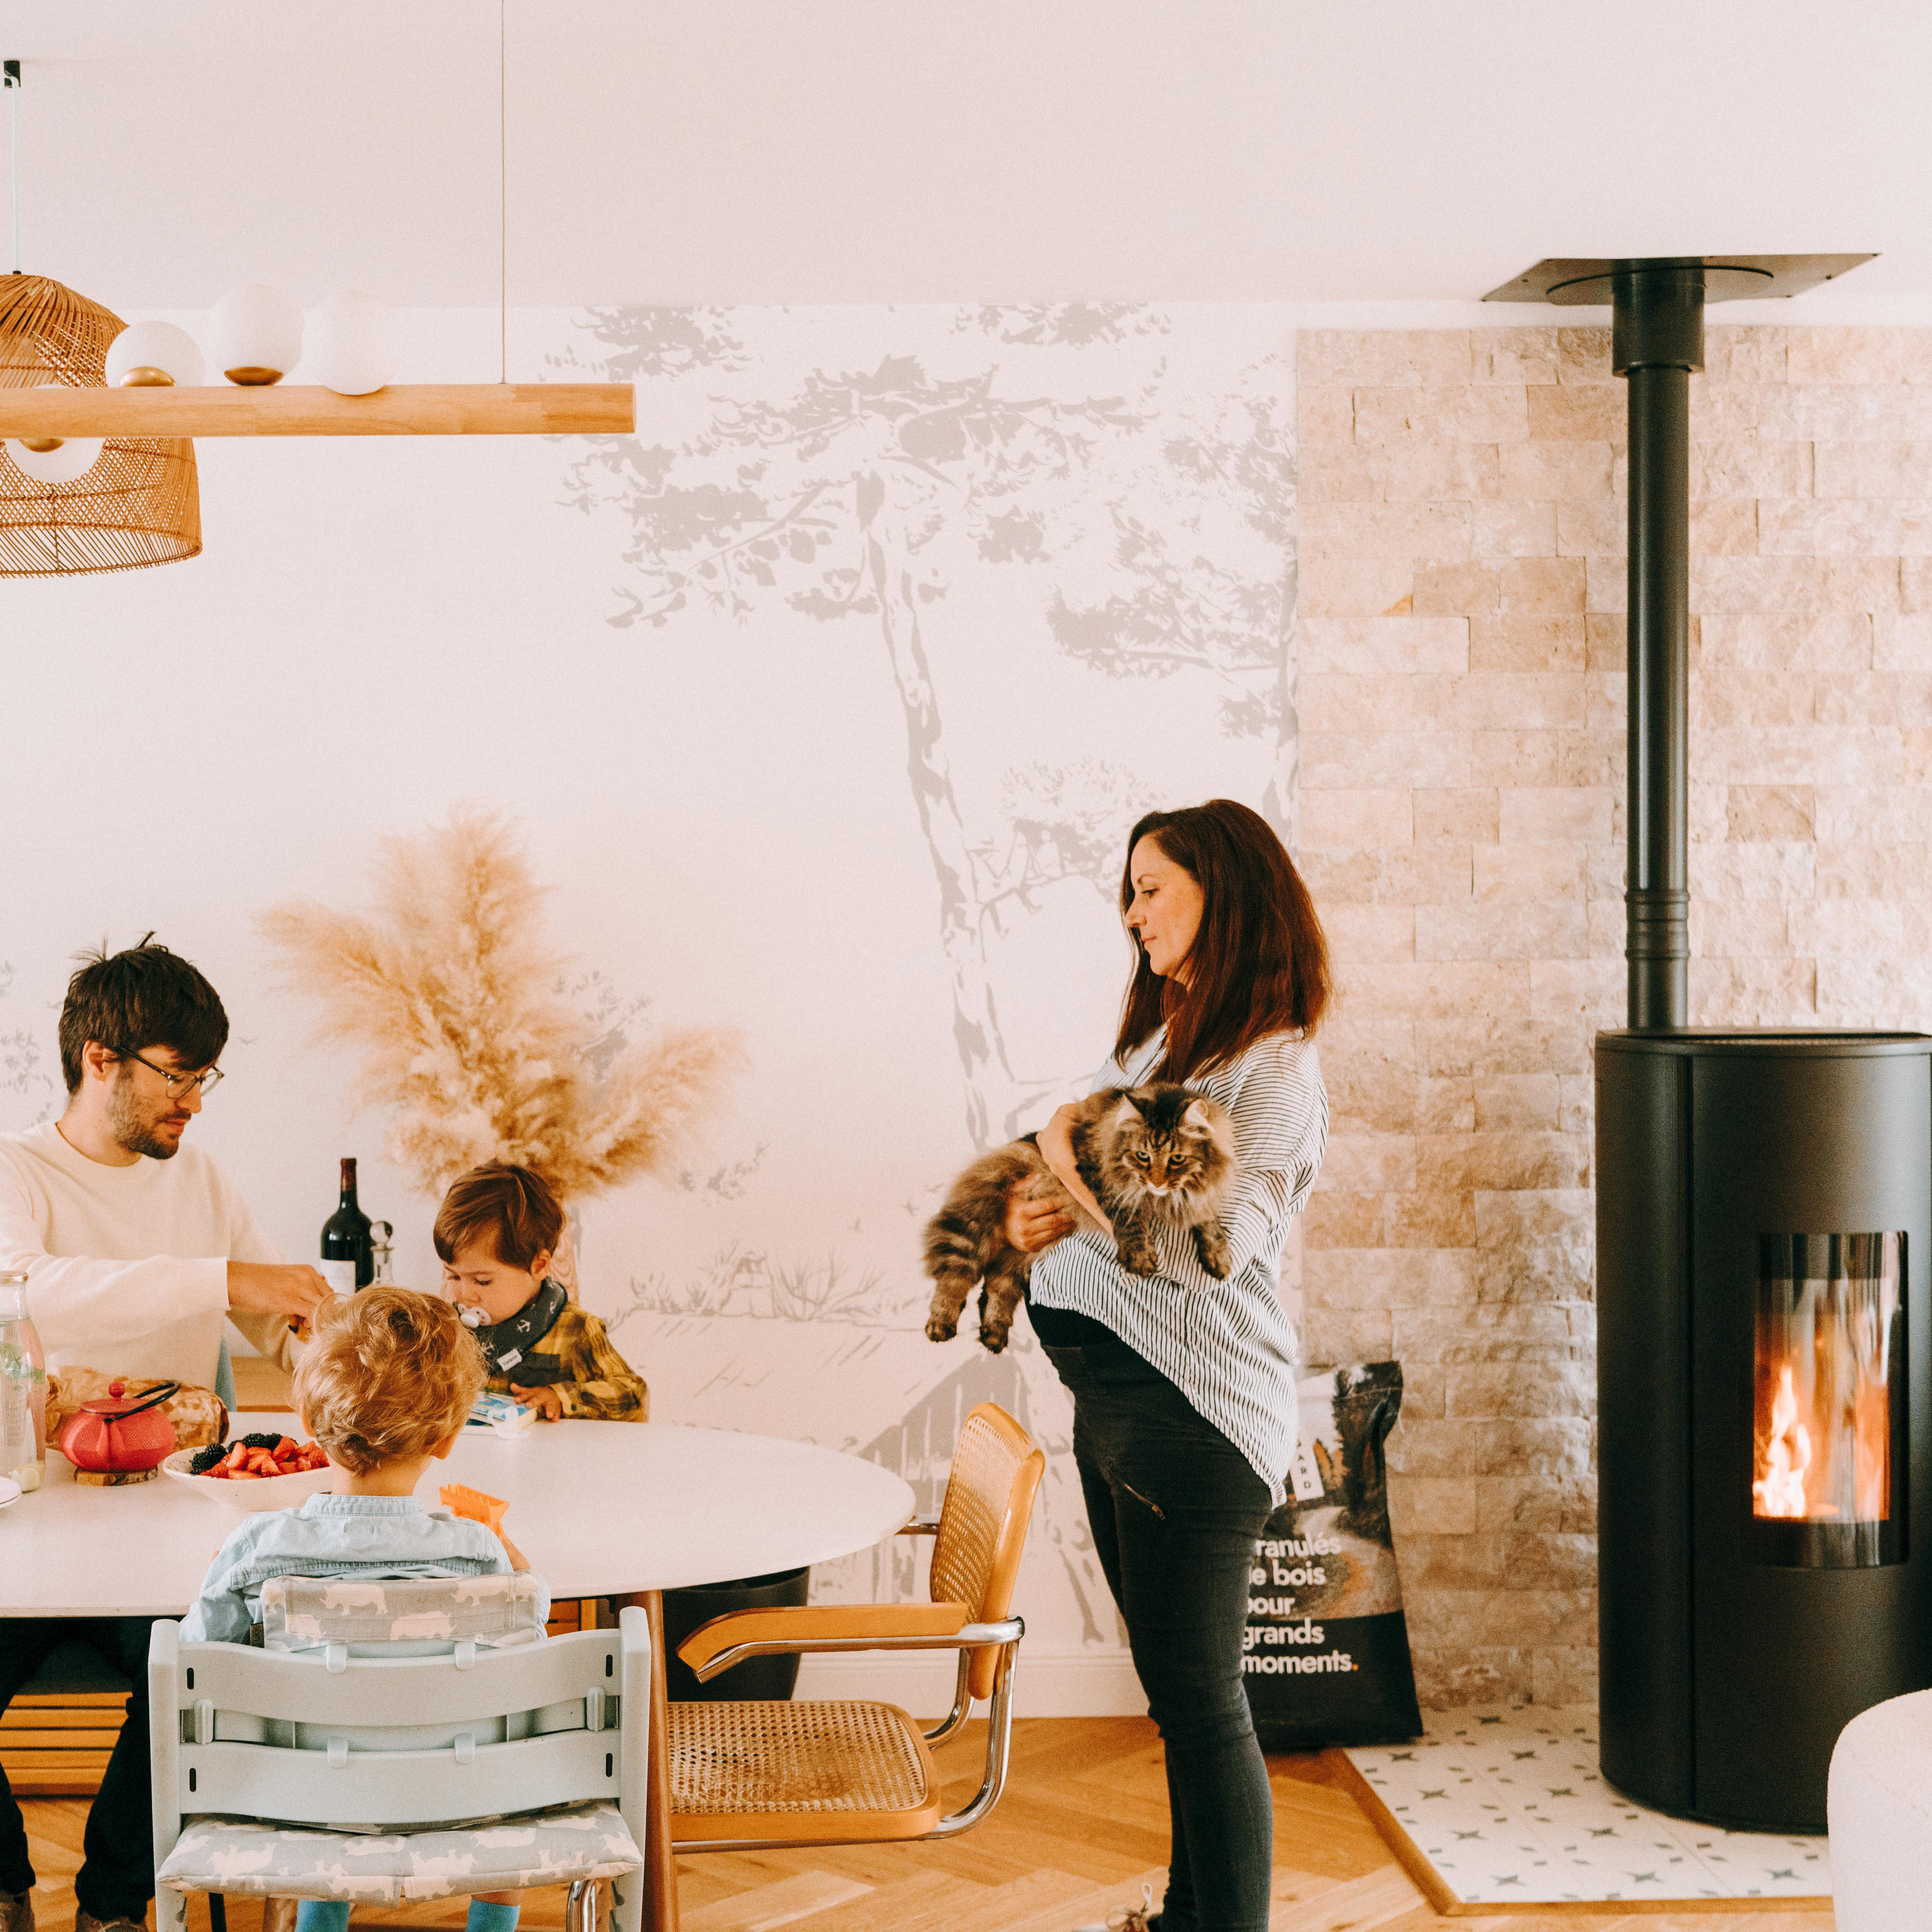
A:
1343;1704;1831;1913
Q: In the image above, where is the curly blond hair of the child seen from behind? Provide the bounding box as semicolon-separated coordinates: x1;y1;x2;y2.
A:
296;1287;485;1476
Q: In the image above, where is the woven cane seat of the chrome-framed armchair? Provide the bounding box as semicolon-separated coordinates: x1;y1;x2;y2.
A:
668;1700;941;1843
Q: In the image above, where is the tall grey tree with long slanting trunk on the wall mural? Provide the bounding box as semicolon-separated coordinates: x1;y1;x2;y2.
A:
572;324;1144;1148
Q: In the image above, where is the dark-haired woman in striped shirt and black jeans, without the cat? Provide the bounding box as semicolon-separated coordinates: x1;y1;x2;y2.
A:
1005;798;1329;1932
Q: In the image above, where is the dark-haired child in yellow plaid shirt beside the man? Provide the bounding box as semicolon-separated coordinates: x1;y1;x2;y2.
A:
435;1161;651;1422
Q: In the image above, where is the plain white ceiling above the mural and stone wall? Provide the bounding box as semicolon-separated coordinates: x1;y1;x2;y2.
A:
22;0;1932;311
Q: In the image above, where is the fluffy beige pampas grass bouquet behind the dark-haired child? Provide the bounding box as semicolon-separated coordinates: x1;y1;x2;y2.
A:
255;807;744;1200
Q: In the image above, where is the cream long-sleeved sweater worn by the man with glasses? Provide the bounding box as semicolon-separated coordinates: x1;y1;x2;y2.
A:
0;1121;288;1389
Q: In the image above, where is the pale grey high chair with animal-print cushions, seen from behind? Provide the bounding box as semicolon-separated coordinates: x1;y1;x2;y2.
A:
147;1576;651;1932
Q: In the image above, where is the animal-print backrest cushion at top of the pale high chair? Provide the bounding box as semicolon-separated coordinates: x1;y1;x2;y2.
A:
261;1571;545;1658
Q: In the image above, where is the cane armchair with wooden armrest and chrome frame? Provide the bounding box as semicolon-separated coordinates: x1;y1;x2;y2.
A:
668;1402;1045;1851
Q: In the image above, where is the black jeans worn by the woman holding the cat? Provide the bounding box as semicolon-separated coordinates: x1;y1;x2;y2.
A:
1047;1339;1275;1932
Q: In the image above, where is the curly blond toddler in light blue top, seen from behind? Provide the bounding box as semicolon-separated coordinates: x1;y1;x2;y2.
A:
182;1287;549;1932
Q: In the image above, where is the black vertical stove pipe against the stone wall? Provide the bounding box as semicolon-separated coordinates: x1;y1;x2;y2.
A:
1611;261;1704;1032
